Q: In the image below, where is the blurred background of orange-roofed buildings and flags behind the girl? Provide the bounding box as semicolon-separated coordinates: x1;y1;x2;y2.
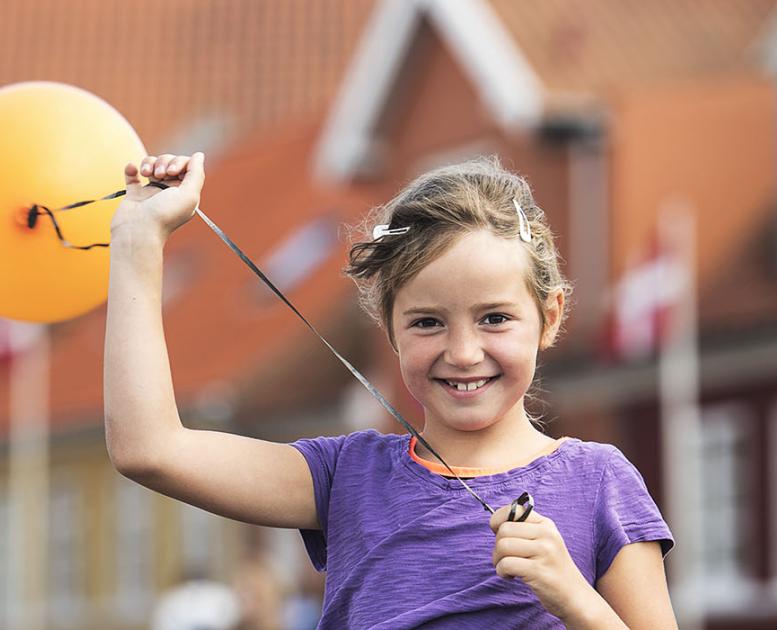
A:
0;0;777;630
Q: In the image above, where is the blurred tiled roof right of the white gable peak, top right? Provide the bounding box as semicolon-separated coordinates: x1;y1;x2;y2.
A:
490;0;777;98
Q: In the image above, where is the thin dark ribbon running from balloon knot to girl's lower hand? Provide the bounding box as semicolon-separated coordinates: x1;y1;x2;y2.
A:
27;182;494;514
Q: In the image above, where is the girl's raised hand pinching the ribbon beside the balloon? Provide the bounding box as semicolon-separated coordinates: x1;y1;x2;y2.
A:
111;153;205;241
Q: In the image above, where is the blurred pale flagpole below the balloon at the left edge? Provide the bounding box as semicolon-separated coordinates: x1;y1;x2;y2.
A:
5;322;49;630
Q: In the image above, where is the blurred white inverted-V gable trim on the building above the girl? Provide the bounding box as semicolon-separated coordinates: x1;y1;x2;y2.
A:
314;0;543;181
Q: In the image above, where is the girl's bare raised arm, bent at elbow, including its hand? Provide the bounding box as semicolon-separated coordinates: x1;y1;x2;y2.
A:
104;153;318;529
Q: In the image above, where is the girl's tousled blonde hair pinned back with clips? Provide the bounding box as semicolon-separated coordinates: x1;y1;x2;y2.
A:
345;156;572;347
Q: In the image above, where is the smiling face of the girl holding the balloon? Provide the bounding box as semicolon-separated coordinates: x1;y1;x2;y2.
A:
392;230;563;431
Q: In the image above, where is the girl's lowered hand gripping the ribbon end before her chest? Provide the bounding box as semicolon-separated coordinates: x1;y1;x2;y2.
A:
490;505;595;620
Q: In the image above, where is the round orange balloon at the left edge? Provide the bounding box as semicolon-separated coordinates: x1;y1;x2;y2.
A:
0;81;146;322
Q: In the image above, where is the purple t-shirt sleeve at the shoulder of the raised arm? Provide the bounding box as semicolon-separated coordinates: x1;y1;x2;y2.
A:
291;436;345;571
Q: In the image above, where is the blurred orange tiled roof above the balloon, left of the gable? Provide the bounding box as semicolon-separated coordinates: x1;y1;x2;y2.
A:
0;0;374;152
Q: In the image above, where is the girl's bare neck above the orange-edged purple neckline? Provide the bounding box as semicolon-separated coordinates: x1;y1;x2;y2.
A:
415;414;554;470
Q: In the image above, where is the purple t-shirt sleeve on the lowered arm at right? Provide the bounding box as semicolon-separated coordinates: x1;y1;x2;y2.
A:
594;448;674;580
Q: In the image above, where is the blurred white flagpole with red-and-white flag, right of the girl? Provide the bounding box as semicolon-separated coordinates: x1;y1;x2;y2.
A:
658;201;704;630
